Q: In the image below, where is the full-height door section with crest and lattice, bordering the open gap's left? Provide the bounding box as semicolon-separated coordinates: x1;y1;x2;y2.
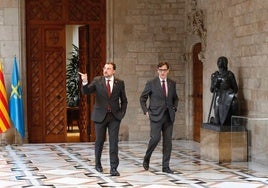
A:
43;26;67;142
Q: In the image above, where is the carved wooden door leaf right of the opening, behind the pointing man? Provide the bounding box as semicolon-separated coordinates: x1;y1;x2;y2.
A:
79;24;106;141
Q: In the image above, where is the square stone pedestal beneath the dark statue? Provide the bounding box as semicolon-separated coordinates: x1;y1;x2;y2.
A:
200;123;248;163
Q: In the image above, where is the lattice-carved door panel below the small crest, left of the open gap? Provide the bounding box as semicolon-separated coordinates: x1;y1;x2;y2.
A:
44;50;66;142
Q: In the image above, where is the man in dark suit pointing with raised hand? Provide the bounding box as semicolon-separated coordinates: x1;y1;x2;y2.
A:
79;62;128;176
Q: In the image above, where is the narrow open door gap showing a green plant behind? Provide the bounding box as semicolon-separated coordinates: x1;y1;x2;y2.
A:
65;25;80;142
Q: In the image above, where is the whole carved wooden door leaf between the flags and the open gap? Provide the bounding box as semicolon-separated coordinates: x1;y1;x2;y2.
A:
27;25;66;142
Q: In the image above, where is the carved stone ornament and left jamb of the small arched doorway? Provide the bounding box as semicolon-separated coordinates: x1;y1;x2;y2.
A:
183;0;207;139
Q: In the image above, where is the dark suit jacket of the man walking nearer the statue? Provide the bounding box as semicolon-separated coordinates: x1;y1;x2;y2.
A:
140;77;179;122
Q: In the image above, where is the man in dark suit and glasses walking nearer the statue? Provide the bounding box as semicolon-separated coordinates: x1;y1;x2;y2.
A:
140;62;179;173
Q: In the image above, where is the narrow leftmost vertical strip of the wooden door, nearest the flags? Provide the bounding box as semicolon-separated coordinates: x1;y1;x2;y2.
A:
27;26;44;143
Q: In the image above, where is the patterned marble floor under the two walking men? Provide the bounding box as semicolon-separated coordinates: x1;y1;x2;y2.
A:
0;140;268;188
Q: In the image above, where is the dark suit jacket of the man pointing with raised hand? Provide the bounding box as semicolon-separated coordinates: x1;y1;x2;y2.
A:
82;76;128;122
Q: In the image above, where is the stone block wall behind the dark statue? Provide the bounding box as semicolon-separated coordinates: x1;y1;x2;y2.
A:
199;0;268;117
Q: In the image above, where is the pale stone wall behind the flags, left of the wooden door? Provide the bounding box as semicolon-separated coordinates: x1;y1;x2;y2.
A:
0;0;26;144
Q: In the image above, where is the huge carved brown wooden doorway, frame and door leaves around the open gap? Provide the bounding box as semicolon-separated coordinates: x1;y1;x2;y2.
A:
25;0;106;143
